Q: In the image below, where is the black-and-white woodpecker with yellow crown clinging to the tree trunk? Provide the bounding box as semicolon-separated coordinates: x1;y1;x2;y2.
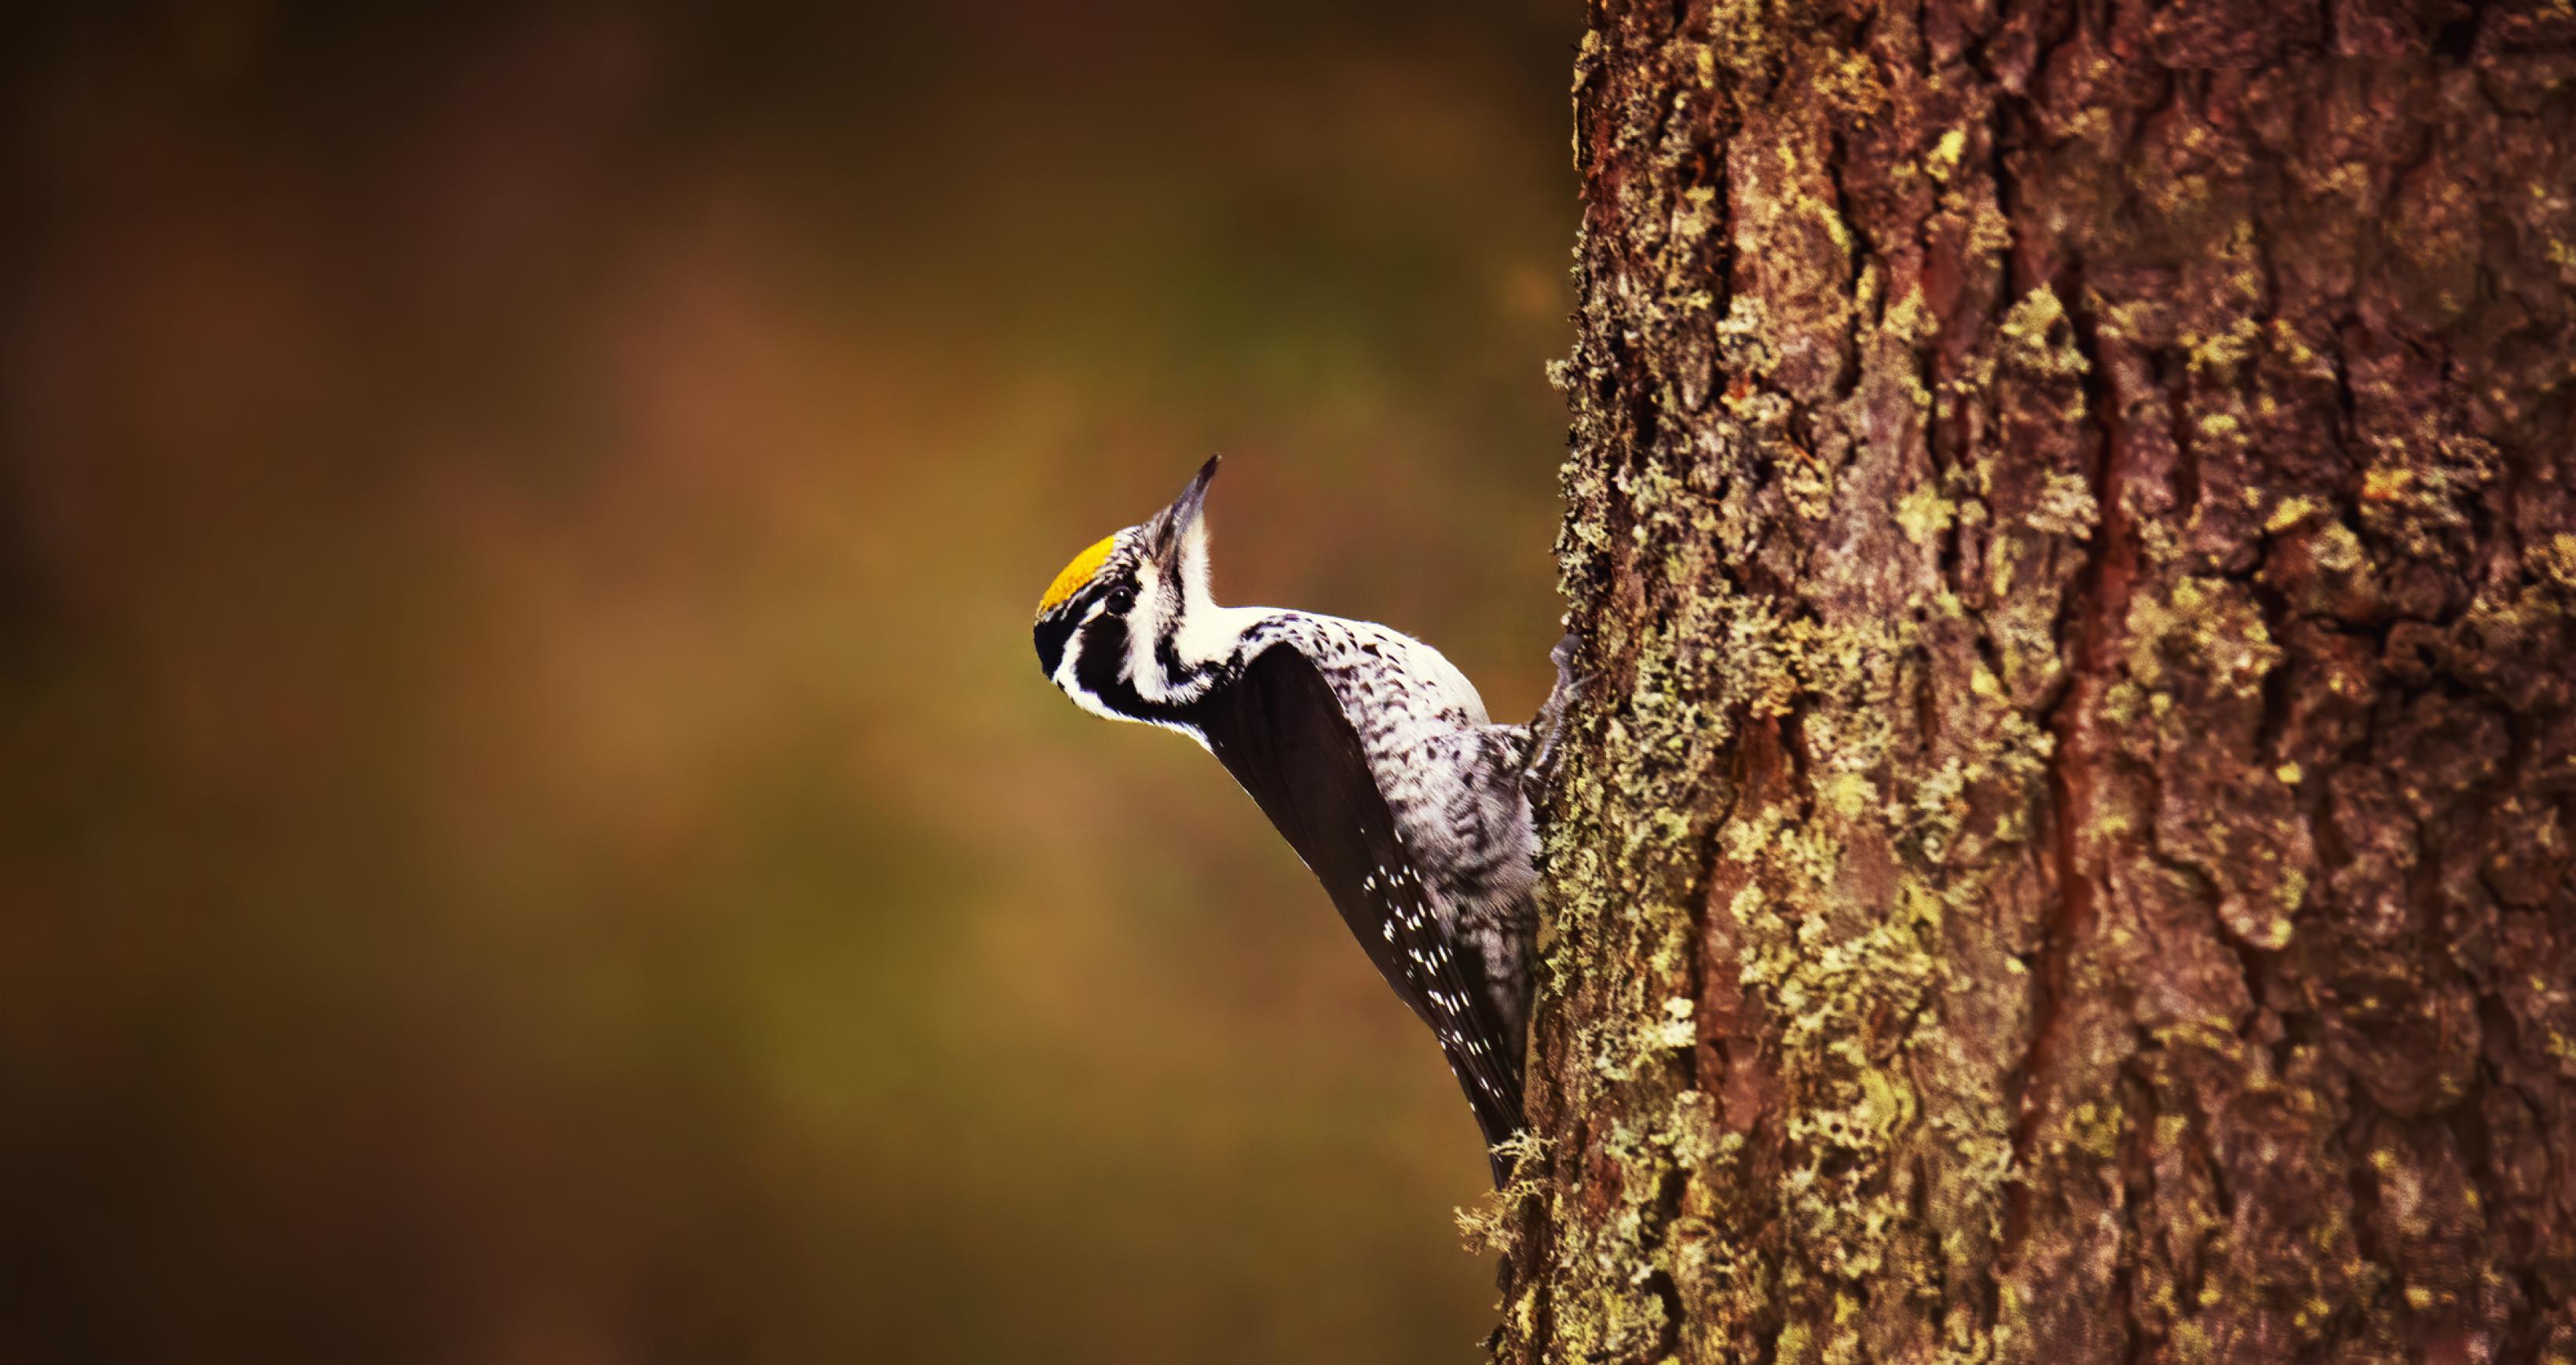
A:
1036;459;1574;1188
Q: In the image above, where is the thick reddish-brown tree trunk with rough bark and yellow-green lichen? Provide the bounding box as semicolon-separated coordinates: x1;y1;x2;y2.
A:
1497;0;2576;1365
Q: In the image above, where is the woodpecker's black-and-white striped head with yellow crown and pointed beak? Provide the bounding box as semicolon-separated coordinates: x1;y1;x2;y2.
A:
1036;456;1218;721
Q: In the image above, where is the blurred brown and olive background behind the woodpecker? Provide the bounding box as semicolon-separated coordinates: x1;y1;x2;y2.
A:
0;0;1579;1365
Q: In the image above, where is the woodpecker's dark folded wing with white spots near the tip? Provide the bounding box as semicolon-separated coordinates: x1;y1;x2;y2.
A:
1190;646;1525;1185
